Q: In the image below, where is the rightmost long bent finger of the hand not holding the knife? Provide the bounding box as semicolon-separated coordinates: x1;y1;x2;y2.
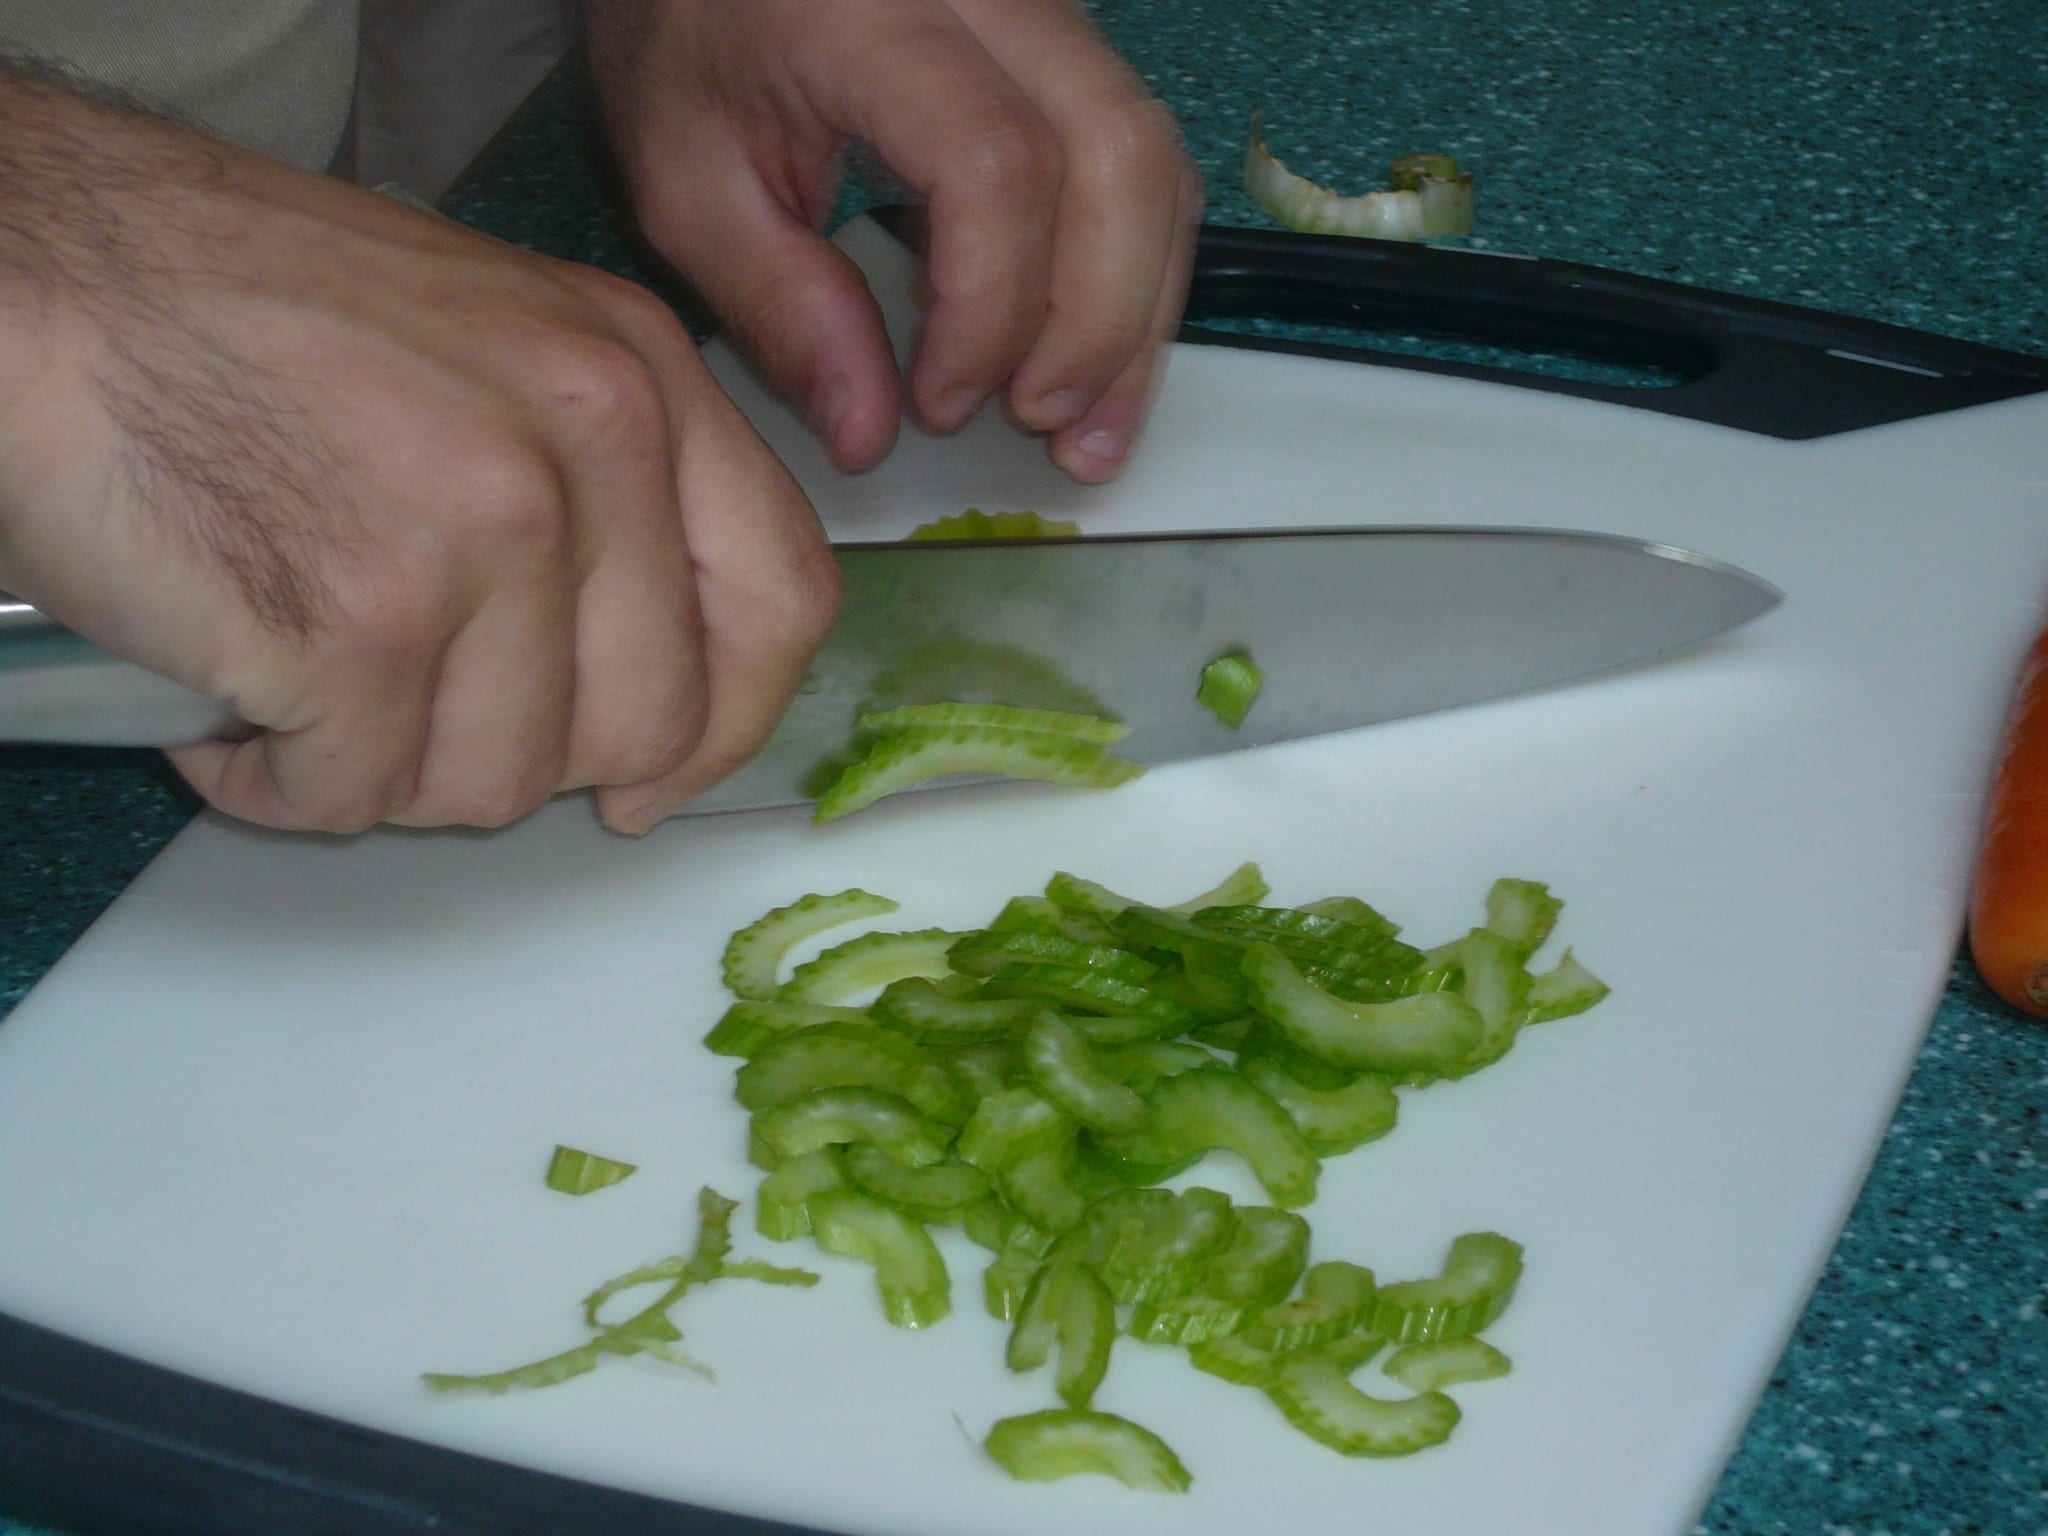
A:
958;0;1198;459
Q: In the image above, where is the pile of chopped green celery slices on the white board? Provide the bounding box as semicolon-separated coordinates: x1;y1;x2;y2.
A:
707;872;1608;1491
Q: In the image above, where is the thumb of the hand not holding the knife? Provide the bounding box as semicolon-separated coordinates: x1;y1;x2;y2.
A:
639;141;903;469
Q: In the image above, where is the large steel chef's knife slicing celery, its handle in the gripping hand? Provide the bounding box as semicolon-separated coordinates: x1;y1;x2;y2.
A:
0;526;1782;815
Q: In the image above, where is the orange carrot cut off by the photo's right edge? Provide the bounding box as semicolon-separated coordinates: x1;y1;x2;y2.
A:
1970;631;2048;1018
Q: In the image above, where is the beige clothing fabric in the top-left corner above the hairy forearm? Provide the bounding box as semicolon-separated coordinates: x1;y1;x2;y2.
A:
0;0;360;170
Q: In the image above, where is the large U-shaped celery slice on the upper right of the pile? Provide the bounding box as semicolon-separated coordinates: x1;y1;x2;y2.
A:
1245;946;1481;1077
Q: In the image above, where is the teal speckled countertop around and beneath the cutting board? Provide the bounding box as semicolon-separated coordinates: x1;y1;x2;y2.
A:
0;0;2048;1536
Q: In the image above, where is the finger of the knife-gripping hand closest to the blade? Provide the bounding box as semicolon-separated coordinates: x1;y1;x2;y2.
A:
598;358;840;831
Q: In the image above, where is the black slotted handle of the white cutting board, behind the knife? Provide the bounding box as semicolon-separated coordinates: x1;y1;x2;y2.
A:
1180;225;2048;438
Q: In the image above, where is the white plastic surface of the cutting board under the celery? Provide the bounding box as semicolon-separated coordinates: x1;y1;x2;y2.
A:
0;219;2048;1536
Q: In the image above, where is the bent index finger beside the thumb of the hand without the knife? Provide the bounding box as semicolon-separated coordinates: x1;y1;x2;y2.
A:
782;0;1063;430
